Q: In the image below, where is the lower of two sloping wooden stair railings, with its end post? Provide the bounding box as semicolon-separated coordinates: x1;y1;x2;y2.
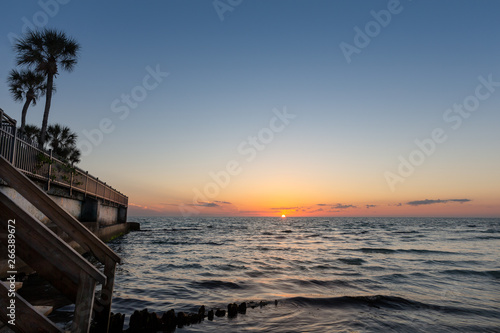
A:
0;192;106;332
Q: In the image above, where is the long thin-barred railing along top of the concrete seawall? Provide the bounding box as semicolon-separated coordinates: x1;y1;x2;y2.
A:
0;109;128;207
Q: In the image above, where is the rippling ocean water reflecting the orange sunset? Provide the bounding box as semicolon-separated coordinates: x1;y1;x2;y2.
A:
106;217;500;332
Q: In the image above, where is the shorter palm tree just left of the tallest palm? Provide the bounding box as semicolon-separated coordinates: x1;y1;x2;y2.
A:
7;69;46;133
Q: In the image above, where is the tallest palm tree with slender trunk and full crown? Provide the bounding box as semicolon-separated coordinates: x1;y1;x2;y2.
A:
14;29;80;147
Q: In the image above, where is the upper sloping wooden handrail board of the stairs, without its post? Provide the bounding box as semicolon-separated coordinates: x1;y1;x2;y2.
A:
0;156;121;264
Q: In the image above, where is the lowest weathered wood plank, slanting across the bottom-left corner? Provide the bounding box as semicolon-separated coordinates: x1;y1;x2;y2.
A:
0;284;64;333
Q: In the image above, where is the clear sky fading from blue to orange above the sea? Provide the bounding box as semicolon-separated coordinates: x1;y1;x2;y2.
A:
0;0;500;217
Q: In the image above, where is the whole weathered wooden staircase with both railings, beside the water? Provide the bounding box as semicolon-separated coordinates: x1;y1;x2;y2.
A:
0;156;121;332
